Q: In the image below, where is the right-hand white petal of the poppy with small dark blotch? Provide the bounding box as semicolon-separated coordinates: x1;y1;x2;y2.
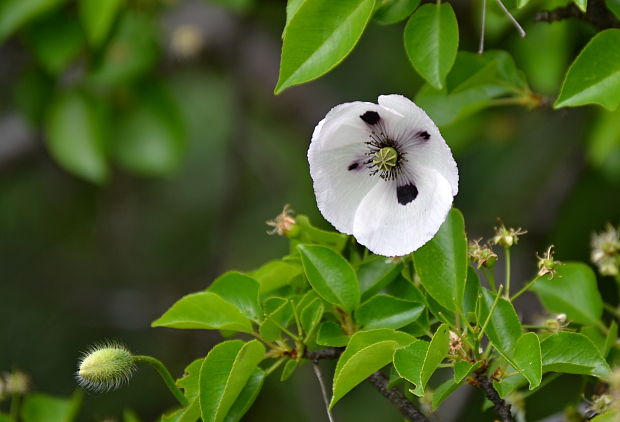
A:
379;95;459;195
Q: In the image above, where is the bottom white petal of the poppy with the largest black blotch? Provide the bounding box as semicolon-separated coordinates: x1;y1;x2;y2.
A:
353;168;452;256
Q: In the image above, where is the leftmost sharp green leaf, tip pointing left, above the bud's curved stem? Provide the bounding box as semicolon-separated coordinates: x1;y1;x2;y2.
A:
151;292;252;333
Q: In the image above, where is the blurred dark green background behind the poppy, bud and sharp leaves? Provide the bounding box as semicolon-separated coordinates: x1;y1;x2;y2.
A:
0;0;620;421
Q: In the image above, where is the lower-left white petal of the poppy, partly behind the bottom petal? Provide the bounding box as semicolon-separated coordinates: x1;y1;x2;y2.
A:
308;142;383;234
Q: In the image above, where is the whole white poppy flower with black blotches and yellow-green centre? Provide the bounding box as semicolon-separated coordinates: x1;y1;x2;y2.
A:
308;95;458;256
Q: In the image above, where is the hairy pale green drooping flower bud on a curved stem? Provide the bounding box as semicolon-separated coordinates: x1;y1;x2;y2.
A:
75;342;136;393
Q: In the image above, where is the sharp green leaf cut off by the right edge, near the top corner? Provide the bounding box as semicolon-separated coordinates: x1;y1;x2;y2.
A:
553;29;620;110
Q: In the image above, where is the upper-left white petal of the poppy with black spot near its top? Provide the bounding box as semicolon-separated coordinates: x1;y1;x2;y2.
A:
312;101;403;152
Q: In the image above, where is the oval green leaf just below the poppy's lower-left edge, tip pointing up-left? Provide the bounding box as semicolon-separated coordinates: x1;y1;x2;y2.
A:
298;245;360;312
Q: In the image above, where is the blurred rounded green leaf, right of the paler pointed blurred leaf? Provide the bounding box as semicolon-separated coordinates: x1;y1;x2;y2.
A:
114;85;186;176
